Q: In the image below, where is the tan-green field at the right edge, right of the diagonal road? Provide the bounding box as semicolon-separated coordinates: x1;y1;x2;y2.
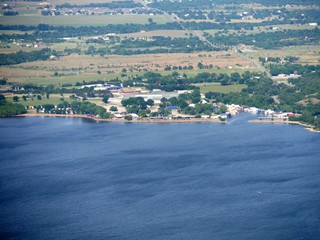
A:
246;45;320;64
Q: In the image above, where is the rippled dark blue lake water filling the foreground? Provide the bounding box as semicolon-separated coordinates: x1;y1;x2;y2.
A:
0;115;320;240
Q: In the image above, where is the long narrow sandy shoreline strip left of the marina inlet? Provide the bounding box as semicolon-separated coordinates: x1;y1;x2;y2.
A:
16;113;225;123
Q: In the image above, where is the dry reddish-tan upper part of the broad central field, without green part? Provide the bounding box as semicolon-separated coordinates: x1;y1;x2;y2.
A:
12;51;252;71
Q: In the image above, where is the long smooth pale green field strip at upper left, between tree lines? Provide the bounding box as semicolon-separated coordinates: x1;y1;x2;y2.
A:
0;14;170;27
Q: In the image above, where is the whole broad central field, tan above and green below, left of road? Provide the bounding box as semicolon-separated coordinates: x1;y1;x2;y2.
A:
0;52;257;85
